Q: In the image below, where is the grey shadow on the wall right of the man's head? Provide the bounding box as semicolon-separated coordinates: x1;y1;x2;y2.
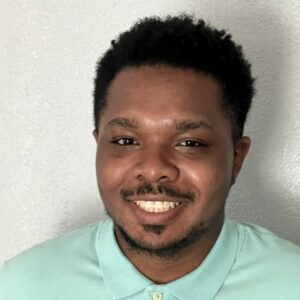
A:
213;4;300;245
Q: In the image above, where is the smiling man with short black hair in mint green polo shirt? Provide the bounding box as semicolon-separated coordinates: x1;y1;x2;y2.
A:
0;15;300;300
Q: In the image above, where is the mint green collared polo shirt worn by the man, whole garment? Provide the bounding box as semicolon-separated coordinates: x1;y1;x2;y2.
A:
0;220;300;300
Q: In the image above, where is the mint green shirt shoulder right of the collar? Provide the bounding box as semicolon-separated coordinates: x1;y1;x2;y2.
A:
218;221;300;300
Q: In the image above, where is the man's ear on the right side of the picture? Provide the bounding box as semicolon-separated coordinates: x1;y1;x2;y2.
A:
231;136;251;185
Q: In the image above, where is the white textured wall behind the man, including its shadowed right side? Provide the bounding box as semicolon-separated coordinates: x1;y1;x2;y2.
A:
0;0;300;264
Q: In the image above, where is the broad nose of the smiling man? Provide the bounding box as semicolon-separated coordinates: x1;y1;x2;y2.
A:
133;149;180;183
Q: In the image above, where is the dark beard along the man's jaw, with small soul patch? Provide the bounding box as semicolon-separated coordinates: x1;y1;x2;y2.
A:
113;216;206;260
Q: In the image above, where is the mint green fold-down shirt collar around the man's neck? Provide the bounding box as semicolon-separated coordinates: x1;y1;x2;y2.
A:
97;219;238;300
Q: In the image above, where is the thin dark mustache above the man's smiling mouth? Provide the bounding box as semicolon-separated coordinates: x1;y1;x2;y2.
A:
120;182;195;201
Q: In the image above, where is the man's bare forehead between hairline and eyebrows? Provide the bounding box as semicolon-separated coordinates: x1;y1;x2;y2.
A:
100;66;227;132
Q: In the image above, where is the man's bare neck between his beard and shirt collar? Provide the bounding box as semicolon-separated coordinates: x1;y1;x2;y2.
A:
116;220;223;284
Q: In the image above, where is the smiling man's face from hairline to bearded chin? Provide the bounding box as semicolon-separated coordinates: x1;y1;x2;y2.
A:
96;67;249;255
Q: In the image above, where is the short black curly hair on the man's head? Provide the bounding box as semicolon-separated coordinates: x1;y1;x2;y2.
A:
94;14;254;141
